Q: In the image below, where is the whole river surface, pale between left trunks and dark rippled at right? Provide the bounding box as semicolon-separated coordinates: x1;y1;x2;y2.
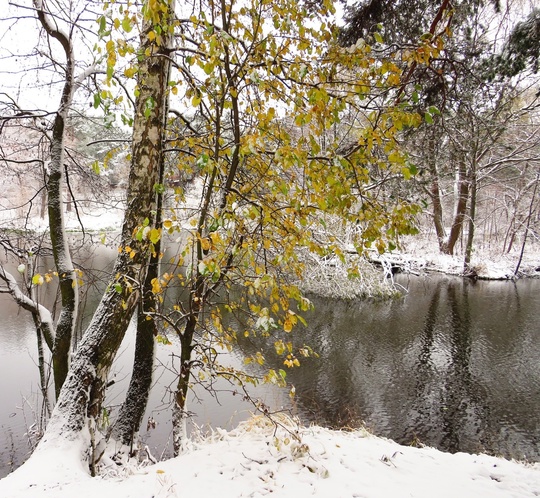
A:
0;260;540;477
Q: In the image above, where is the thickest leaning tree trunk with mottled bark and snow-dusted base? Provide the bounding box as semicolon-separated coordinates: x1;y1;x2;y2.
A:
38;0;173;474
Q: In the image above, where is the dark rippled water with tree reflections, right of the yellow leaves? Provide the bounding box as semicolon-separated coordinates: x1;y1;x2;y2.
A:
262;277;540;460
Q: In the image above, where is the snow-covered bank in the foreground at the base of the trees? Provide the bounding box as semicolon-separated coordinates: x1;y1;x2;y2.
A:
0;417;540;498
